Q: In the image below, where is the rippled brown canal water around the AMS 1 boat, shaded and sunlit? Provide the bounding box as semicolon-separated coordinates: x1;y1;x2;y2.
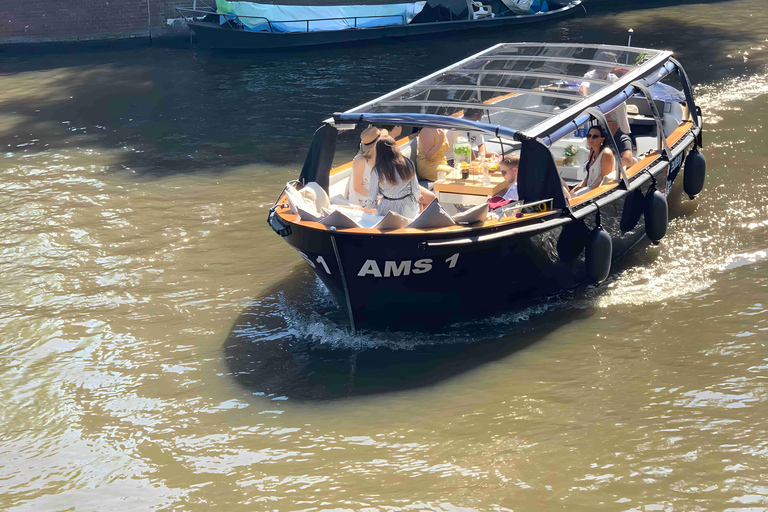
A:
0;0;768;512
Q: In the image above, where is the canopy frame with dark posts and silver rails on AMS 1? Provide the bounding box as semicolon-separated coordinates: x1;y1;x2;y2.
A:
300;43;699;213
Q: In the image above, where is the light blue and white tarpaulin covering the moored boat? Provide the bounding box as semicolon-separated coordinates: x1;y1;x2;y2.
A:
216;0;426;32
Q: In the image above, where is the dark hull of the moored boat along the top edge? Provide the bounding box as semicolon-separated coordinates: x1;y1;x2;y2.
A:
189;0;581;50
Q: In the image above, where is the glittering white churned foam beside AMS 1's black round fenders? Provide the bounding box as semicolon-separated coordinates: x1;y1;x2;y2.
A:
593;71;768;307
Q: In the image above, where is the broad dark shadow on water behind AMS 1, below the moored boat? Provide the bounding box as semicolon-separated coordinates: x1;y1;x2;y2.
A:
0;8;751;178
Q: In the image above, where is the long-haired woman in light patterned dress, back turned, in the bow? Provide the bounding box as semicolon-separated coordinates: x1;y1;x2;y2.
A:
363;136;421;218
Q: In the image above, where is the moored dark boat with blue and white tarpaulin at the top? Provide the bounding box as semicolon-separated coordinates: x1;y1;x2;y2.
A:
177;0;586;50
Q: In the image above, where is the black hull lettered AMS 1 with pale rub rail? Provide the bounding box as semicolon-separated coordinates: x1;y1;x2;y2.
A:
278;133;694;331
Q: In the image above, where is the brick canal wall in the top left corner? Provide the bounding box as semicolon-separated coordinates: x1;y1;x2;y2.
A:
0;0;195;44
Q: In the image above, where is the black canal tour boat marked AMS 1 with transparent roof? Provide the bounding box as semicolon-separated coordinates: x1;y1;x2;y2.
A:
268;43;706;330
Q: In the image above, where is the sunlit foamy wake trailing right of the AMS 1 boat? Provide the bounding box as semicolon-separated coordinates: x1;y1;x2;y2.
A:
593;71;768;308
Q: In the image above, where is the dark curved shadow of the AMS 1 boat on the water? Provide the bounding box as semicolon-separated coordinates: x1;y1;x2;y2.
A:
223;267;592;401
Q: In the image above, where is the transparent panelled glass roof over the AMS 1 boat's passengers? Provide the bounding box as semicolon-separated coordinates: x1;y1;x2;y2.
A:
339;43;671;140
